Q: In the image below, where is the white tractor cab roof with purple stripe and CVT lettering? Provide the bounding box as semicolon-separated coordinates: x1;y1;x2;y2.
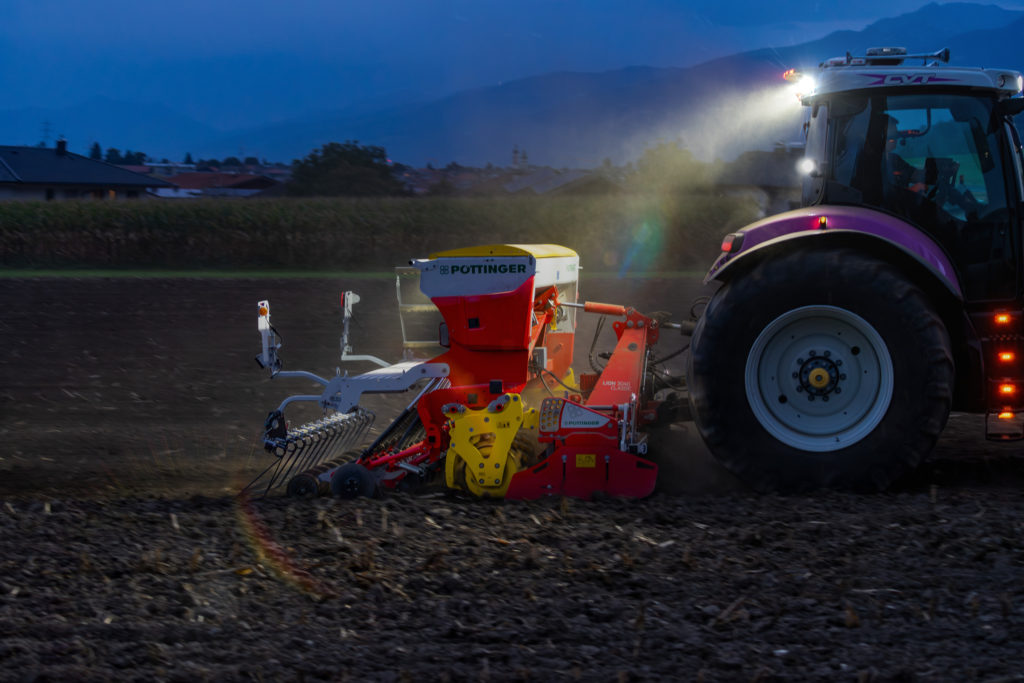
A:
802;47;1022;104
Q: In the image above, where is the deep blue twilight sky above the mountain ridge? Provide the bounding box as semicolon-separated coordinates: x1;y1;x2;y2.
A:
0;0;1024;129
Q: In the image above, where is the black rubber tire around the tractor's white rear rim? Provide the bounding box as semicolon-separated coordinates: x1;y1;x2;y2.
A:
687;248;954;493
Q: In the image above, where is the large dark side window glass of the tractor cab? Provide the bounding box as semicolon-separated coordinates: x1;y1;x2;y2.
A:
829;93;1017;300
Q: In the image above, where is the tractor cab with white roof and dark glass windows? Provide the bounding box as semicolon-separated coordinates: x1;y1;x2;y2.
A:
803;48;1024;301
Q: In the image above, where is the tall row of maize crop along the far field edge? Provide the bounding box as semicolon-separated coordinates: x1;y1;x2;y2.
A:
0;196;756;270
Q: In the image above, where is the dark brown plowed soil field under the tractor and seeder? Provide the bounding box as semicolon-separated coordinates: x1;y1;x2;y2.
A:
0;276;1024;681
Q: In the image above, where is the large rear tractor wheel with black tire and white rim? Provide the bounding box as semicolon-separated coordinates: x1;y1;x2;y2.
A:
688;249;953;492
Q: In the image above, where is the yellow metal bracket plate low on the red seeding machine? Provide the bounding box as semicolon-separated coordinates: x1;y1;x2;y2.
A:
444;393;538;498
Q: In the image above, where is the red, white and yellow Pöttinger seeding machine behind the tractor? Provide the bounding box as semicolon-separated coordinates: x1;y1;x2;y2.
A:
247;245;694;499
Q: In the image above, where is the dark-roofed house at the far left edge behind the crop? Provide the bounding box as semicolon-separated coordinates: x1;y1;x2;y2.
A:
0;140;172;200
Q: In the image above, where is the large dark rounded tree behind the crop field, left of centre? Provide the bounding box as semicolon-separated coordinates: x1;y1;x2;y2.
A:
289;140;407;197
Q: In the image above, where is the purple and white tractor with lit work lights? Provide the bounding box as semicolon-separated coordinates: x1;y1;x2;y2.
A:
686;47;1024;492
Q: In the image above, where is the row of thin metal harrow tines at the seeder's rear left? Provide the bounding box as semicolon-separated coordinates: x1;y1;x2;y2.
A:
243;409;374;498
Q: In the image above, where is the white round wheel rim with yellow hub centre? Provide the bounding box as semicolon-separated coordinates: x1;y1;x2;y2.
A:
743;306;893;452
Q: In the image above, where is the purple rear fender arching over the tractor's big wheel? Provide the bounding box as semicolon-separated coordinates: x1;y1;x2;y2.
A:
705;206;964;301
